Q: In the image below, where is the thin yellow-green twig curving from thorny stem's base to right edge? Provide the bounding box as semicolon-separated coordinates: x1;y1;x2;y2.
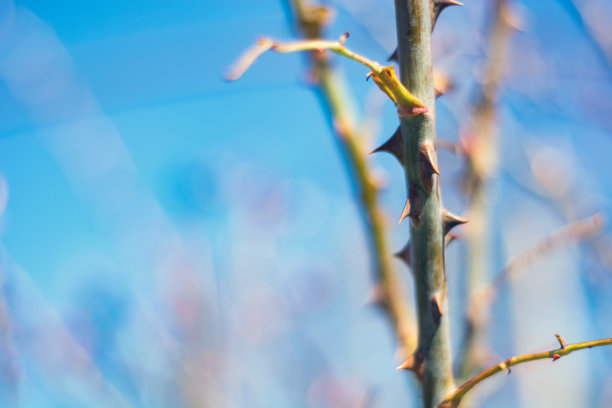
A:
437;334;612;408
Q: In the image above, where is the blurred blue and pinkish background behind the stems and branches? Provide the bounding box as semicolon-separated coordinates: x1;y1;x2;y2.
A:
0;0;612;408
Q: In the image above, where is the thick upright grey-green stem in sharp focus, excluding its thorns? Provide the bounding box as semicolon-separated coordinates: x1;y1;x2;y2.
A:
395;0;454;408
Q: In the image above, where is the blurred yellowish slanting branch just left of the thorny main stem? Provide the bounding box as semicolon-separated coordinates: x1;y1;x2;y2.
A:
282;0;416;358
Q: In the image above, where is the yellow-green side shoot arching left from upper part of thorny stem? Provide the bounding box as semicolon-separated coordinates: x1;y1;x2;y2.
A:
226;32;429;118
